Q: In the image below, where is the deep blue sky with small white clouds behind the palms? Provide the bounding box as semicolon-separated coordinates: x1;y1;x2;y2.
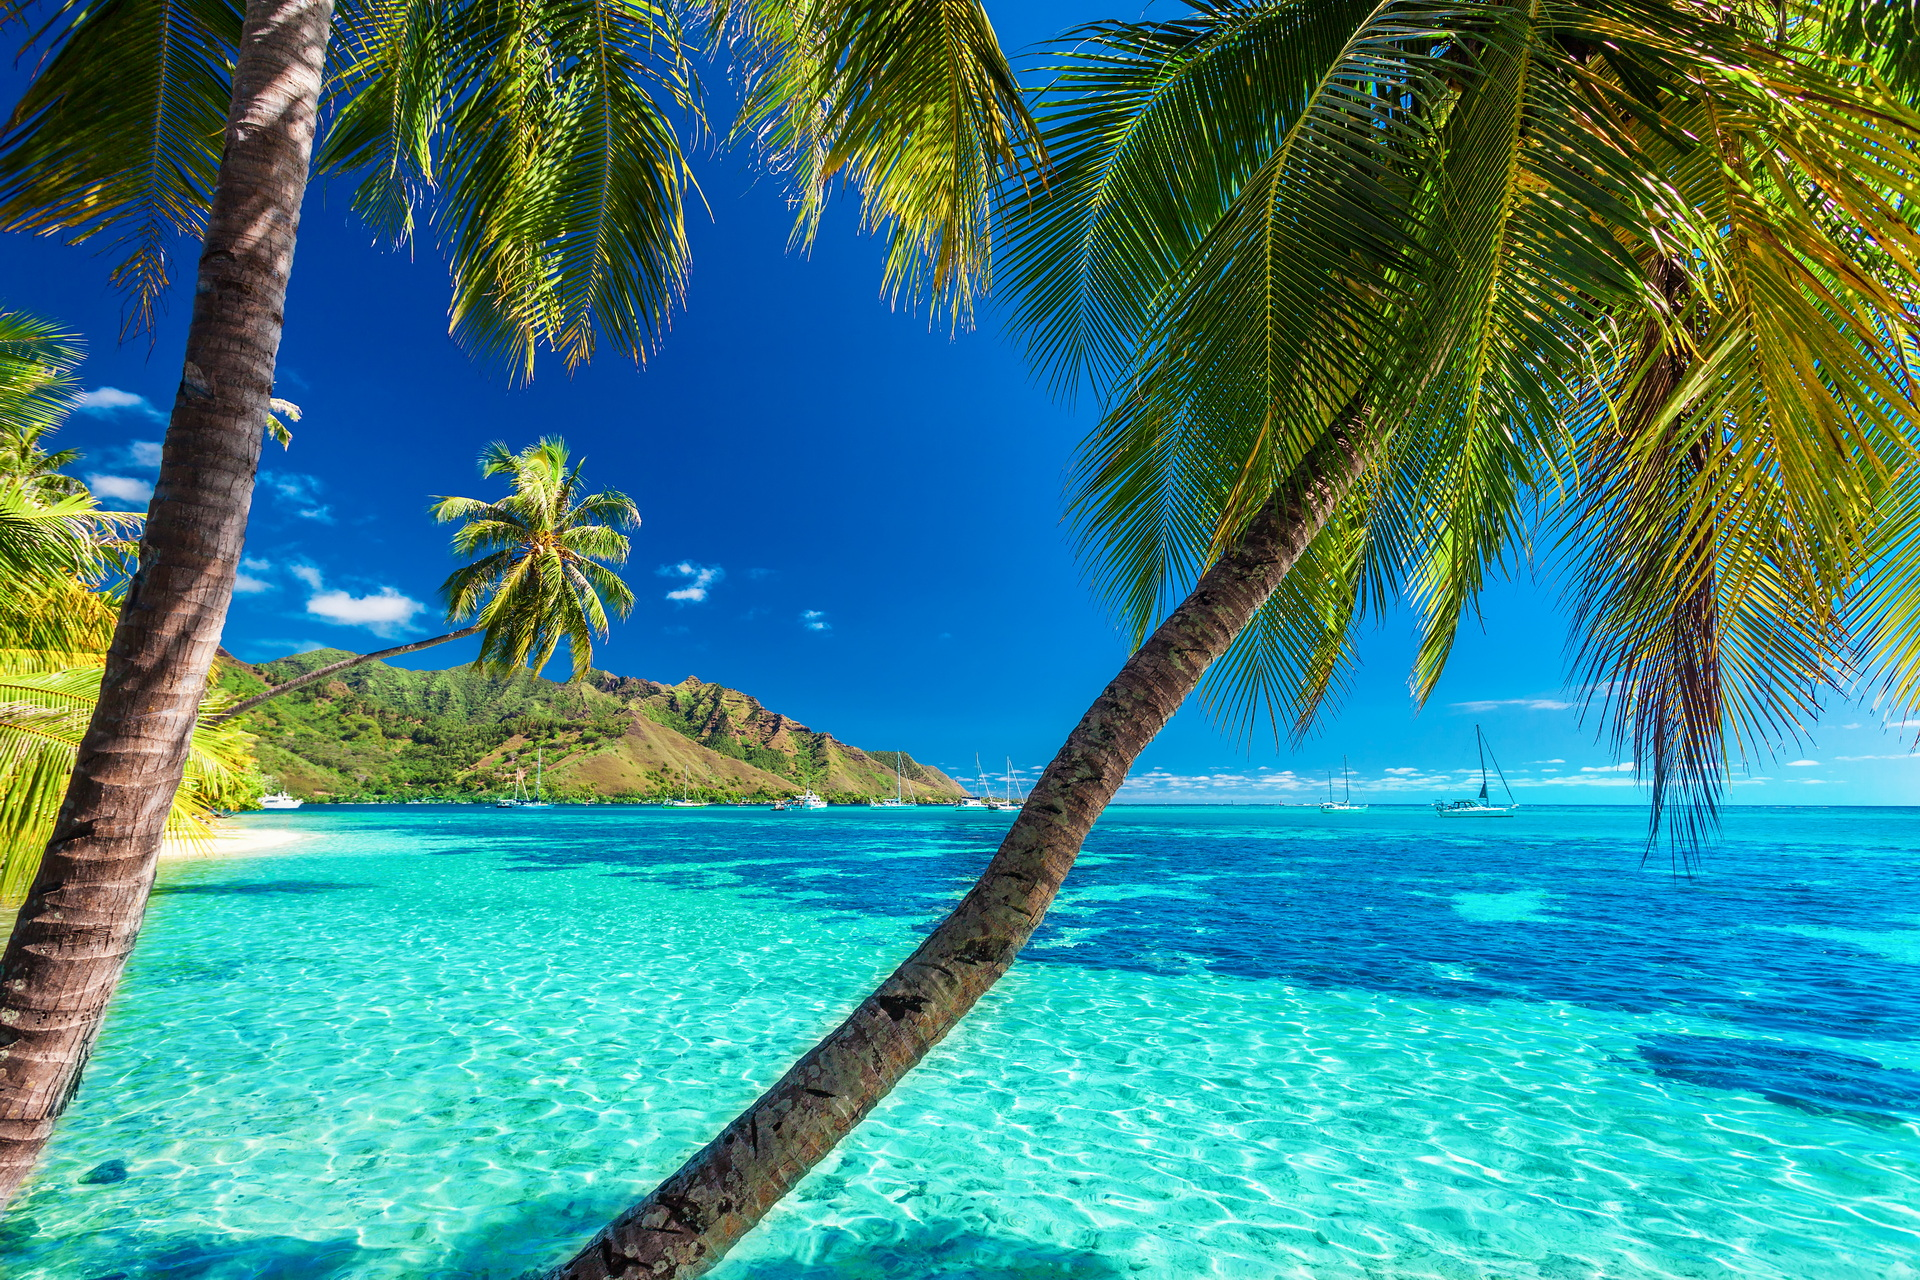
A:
0;4;1920;804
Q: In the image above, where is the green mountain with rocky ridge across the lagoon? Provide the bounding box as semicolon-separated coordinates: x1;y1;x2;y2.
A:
219;649;964;800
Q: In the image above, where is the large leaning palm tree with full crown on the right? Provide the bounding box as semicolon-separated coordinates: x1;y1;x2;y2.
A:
557;0;1920;1280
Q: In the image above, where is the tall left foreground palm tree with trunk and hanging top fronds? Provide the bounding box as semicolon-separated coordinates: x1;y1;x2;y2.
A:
0;0;1033;1201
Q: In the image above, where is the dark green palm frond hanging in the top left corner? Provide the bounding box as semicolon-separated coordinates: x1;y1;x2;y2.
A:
0;0;240;332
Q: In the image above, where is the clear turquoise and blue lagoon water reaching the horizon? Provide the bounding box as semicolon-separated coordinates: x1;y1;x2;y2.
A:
0;806;1920;1280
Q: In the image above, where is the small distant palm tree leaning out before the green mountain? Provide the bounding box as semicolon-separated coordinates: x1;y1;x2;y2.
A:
211;436;639;723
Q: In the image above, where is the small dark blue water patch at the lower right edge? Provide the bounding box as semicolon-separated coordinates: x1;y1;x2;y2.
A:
1638;1034;1920;1121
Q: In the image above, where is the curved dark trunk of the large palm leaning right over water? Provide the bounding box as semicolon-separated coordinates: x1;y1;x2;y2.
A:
551;420;1363;1280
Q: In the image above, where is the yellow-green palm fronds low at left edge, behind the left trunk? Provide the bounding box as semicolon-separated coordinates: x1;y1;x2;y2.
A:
0;649;259;904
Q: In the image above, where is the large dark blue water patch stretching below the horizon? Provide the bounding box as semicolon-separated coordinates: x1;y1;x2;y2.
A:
464;810;1920;1040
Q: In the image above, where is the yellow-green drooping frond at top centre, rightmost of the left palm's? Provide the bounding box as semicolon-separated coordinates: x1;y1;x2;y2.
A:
712;0;1044;328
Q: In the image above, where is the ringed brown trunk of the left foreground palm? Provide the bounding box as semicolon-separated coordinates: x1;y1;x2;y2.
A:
0;0;332;1203
